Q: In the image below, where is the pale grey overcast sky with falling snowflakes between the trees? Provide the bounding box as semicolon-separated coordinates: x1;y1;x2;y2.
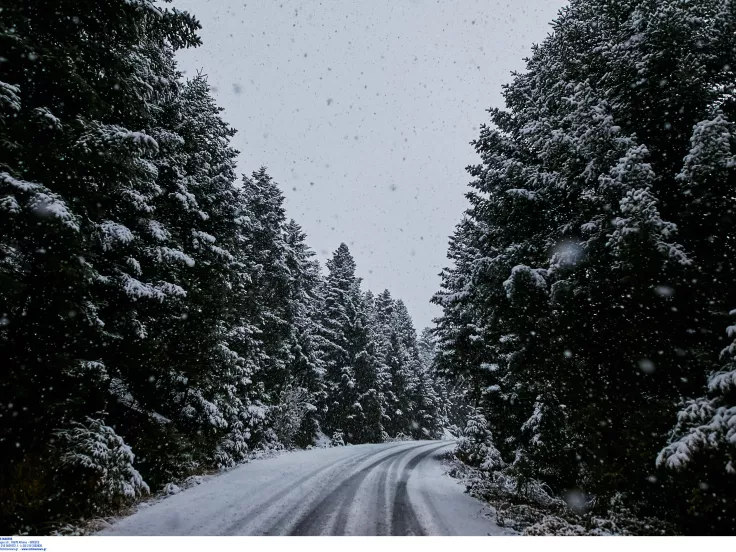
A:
174;0;565;330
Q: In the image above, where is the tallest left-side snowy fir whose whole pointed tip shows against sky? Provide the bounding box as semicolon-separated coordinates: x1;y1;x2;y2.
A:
142;75;253;474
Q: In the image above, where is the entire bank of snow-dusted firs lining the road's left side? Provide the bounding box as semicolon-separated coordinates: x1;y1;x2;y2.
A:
0;0;446;533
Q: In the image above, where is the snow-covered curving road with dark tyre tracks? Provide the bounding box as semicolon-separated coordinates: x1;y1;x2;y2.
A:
100;441;505;535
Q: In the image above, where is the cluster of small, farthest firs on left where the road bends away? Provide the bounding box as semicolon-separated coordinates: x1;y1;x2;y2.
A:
318;244;442;442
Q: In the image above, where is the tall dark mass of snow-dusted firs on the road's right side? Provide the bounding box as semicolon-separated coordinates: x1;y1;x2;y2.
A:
434;0;736;532
